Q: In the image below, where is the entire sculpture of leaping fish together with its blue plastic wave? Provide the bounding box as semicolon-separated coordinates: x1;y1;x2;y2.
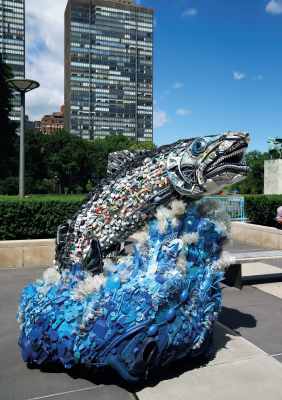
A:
18;132;249;382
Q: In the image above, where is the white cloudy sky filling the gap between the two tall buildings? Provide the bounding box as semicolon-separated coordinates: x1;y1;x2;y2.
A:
26;0;67;120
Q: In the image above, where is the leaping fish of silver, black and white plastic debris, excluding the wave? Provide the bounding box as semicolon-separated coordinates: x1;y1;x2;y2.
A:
55;131;249;273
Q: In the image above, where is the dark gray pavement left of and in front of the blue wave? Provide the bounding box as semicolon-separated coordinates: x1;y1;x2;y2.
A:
0;268;136;400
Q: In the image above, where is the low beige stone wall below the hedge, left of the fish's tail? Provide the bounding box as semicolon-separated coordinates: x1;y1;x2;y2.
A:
0;239;55;268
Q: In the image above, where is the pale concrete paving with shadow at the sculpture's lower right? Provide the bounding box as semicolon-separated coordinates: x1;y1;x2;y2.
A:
136;324;282;400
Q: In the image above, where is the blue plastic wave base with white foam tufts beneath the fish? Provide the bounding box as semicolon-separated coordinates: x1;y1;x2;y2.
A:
18;203;224;382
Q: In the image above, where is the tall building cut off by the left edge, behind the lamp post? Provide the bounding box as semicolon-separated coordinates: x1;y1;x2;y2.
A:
0;0;25;121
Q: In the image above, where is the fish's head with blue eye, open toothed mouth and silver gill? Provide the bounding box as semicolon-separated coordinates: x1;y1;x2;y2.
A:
166;131;250;199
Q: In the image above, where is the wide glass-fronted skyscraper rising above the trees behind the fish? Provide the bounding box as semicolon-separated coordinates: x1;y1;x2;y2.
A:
64;0;153;142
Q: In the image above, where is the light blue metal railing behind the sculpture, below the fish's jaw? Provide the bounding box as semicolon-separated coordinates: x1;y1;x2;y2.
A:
199;196;245;222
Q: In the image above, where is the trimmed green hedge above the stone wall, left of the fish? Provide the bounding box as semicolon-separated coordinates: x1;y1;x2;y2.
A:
0;195;85;240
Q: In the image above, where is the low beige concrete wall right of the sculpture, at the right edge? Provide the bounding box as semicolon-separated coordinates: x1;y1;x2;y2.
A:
231;221;282;250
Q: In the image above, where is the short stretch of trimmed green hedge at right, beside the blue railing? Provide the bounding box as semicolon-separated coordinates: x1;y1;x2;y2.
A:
245;194;282;227
